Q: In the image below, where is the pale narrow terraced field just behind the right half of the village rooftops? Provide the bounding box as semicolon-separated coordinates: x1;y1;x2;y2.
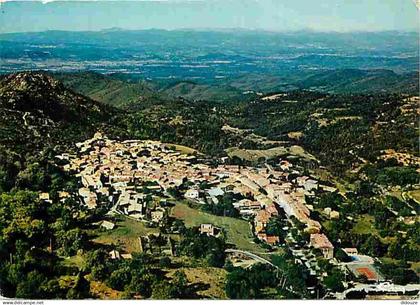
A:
225;145;316;161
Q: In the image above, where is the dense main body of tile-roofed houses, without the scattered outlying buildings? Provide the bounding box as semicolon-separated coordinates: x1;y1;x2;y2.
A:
57;133;337;258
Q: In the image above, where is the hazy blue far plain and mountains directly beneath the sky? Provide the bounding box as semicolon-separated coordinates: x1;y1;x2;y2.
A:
0;30;419;78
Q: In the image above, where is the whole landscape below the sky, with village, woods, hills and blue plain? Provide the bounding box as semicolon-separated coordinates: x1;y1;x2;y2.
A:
0;25;420;300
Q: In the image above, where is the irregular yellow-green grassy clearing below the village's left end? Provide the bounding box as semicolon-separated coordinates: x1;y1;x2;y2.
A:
93;217;159;253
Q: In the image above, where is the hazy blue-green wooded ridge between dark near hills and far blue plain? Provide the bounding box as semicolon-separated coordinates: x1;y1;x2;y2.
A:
53;69;419;107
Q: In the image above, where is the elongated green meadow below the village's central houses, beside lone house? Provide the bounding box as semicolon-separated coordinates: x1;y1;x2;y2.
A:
171;203;266;252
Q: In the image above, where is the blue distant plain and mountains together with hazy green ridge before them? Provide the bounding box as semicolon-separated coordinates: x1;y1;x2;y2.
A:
0;29;419;106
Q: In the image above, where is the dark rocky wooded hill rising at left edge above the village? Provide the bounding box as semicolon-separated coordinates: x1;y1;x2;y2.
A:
0;73;118;190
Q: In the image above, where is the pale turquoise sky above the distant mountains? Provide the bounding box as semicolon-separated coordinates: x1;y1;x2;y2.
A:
0;0;419;32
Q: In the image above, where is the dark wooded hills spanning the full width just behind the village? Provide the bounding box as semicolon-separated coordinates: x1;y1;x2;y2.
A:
0;73;418;188
